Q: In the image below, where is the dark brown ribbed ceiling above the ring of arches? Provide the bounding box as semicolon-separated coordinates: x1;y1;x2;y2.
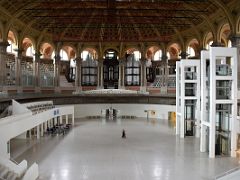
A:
0;0;238;42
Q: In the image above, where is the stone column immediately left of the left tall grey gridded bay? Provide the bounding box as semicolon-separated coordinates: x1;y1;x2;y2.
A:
75;57;82;93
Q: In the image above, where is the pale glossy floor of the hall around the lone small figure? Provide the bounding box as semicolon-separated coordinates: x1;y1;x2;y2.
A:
11;119;239;180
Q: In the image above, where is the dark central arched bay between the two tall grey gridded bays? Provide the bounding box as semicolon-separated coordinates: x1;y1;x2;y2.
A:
103;50;119;89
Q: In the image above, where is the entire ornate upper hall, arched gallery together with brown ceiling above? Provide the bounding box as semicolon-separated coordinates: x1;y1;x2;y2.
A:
0;0;240;93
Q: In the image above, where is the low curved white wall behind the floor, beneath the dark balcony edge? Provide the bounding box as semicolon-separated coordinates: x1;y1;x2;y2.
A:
74;104;176;119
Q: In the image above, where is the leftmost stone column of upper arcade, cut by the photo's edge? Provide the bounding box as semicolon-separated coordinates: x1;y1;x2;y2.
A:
0;41;9;91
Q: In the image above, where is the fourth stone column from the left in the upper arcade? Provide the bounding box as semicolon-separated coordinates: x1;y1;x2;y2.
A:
54;54;61;93
